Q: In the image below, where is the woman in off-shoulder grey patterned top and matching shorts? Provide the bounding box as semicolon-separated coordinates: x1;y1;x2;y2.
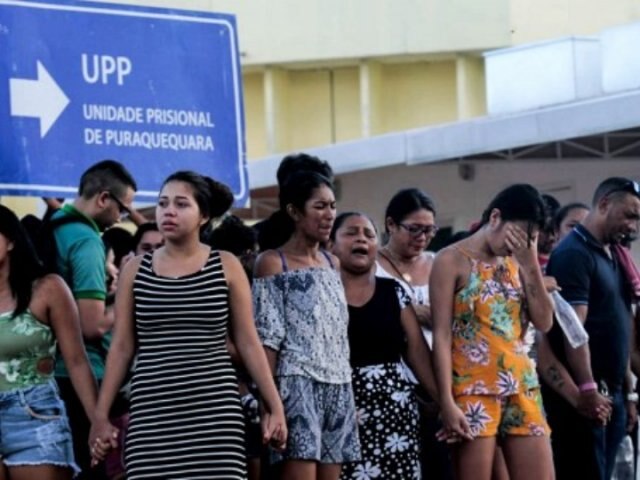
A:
253;161;360;480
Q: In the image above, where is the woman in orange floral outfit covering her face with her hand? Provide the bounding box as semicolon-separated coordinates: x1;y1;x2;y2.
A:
430;184;553;480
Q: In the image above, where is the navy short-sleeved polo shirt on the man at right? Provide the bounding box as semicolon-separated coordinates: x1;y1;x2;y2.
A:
547;225;631;389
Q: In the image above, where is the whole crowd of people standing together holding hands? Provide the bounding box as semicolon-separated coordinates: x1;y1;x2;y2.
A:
0;154;640;480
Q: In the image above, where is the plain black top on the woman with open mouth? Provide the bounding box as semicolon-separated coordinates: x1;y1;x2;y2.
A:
349;277;406;367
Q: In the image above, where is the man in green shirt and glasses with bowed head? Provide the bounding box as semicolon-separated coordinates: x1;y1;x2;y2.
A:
52;160;137;480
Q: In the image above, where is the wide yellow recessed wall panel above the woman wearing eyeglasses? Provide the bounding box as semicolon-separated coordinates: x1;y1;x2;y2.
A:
377;61;457;133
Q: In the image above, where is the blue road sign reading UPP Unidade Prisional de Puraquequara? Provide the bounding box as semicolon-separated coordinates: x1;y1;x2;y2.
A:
0;0;248;206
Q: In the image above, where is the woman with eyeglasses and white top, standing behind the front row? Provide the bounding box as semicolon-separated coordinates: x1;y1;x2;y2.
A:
376;188;451;478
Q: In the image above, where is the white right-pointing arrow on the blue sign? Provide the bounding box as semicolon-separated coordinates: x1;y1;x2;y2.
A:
9;61;69;138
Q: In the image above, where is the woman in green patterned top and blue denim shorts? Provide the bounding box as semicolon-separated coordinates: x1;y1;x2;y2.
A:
0;205;112;480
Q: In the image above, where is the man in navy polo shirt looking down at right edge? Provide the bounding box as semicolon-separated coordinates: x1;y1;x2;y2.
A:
543;177;640;480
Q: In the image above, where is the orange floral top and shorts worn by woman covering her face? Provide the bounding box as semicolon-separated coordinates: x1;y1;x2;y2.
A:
452;248;550;437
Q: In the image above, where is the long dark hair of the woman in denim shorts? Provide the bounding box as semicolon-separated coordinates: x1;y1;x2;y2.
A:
0;205;45;318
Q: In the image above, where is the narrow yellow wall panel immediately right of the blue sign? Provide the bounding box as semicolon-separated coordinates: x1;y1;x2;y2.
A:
242;72;269;158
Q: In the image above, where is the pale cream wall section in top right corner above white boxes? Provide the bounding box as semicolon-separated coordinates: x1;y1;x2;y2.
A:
511;0;640;44
